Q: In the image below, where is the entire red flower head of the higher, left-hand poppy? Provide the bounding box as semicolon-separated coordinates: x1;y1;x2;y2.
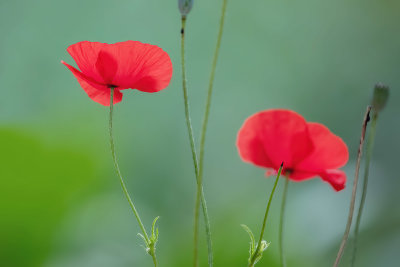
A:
61;41;172;106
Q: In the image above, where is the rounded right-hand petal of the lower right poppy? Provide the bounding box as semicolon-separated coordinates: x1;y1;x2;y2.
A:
295;122;349;172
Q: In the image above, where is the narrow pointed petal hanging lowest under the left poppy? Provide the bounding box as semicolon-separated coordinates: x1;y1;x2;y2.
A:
61;61;122;106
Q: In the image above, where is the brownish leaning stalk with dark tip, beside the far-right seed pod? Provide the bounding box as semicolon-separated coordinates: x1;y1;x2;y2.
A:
333;106;371;267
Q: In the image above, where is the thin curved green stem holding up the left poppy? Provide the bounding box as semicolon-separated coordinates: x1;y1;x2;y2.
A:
109;87;157;267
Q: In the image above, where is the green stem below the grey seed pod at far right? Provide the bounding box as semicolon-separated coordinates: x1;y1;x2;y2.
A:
351;112;378;266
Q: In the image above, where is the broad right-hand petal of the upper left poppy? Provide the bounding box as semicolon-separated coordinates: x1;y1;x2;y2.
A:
103;41;172;93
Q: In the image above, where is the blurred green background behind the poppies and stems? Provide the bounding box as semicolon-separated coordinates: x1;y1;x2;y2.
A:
0;0;400;267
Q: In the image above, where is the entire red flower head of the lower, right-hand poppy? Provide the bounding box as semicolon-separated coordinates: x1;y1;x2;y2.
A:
237;109;349;191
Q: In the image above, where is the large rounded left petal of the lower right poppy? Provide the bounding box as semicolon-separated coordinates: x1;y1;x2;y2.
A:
237;109;313;169
